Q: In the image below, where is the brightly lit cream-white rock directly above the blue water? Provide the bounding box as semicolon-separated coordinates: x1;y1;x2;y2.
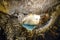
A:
23;14;40;25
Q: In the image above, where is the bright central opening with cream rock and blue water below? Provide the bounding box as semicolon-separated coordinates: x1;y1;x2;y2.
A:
22;14;40;30
